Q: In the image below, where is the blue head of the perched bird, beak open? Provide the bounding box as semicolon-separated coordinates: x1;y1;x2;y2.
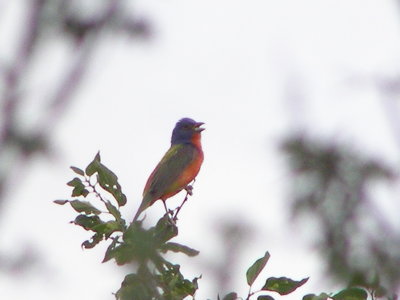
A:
171;118;205;144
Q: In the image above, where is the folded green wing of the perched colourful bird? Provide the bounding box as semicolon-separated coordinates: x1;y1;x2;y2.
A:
143;144;198;205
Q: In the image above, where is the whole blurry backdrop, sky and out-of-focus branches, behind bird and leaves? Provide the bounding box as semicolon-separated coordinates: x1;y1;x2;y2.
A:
0;0;400;300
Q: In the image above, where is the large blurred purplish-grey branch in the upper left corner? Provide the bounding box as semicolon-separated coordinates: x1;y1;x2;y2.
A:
0;0;150;211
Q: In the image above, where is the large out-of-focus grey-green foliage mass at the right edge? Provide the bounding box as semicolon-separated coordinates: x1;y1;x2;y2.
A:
283;136;400;300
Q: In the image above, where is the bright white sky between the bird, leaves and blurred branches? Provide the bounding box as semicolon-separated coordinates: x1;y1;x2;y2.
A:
0;0;400;300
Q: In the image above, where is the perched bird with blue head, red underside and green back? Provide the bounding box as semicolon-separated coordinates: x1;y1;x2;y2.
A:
133;118;204;221
